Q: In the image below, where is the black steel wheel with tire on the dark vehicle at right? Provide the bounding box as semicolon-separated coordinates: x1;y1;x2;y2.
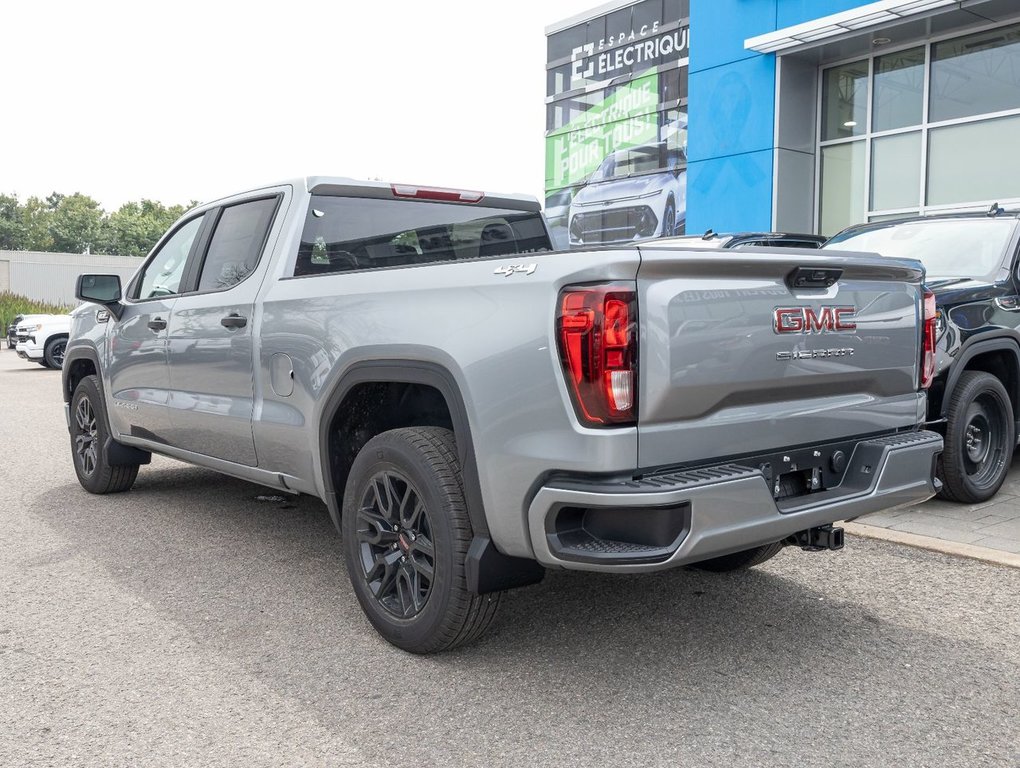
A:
938;370;1016;504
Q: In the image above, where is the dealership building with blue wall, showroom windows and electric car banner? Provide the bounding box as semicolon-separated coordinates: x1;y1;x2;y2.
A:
546;0;1020;245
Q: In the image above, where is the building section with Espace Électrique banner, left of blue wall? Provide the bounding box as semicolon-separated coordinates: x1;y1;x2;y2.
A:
545;0;690;248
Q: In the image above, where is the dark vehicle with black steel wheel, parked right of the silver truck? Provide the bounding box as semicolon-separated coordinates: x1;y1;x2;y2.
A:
822;204;1020;504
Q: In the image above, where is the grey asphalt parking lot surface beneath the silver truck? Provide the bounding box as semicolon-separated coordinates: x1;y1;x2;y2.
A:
0;351;1020;766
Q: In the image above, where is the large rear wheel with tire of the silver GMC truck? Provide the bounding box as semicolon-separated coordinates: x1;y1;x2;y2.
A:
341;426;500;654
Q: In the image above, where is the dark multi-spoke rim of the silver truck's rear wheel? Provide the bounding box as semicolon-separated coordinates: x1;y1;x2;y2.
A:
357;469;436;619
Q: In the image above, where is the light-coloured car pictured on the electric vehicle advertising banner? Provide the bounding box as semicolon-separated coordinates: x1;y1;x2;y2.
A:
567;142;687;243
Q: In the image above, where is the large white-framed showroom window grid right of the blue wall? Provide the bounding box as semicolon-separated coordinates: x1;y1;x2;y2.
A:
817;24;1020;235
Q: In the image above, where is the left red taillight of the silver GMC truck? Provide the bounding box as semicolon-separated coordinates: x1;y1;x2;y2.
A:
556;284;638;426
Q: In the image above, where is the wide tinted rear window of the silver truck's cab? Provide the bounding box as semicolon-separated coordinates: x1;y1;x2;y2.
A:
294;195;552;276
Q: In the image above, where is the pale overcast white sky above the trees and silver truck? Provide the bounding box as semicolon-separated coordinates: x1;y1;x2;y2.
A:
0;0;604;211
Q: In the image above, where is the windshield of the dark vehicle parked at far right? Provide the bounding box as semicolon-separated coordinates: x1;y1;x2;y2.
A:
822;218;1016;283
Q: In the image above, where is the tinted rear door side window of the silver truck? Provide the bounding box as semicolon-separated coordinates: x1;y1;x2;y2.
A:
198;197;278;291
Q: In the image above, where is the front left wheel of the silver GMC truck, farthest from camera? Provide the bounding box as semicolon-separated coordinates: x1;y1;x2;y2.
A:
70;375;139;494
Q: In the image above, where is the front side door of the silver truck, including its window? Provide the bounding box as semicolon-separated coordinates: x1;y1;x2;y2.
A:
107;214;205;443
